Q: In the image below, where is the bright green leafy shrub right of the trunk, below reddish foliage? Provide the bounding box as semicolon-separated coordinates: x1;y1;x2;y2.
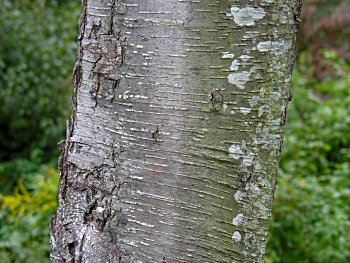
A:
266;53;350;263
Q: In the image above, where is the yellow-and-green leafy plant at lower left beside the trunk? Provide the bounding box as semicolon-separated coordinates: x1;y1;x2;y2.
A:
0;166;58;263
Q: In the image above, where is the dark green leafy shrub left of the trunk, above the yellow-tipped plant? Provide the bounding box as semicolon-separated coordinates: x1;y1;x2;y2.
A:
0;0;79;161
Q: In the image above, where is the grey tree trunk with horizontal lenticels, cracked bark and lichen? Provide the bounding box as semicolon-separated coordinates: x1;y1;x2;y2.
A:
51;0;301;263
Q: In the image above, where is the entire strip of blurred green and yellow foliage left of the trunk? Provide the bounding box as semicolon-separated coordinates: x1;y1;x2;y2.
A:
0;0;80;263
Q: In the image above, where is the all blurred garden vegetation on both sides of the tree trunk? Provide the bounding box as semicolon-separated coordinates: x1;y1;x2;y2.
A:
0;0;350;263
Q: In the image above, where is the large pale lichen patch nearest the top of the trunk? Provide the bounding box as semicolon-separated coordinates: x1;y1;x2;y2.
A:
227;6;266;26
